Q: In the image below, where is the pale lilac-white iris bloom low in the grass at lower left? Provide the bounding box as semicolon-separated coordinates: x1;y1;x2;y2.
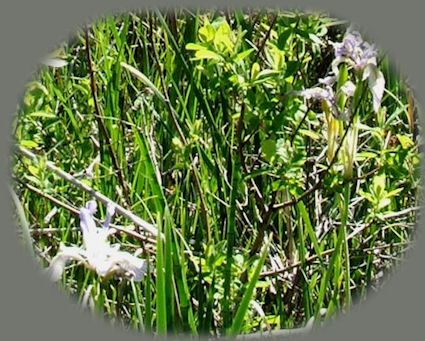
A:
47;201;146;281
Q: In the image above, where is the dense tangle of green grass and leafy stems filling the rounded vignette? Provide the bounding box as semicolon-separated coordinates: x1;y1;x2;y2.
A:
13;10;419;336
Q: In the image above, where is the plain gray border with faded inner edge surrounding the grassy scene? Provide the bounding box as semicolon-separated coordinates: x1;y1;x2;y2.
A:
0;0;425;341
